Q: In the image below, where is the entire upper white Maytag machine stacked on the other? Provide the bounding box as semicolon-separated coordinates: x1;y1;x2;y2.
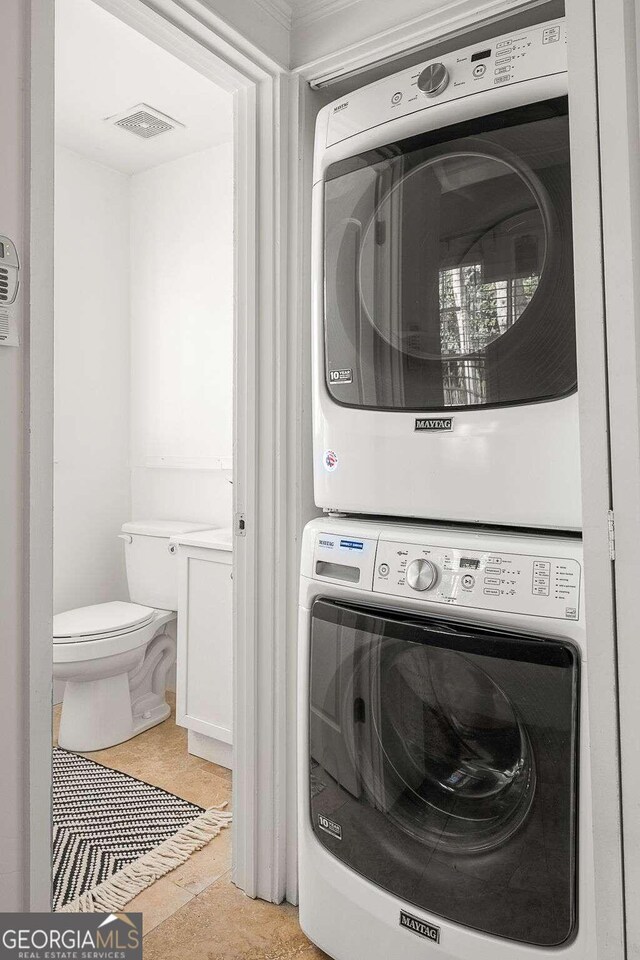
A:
313;20;581;530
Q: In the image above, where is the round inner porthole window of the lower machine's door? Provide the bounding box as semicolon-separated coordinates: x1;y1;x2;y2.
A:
362;638;536;853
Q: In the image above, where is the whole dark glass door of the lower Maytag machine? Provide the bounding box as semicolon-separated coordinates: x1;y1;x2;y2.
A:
309;600;578;946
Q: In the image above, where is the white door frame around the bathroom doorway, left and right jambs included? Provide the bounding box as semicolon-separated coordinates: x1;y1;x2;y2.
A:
26;0;298;910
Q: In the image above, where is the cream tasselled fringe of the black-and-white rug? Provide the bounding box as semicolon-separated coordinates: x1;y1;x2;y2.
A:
58;803;232;913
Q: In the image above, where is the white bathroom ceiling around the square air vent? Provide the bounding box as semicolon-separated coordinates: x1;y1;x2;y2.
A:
56;0;233;174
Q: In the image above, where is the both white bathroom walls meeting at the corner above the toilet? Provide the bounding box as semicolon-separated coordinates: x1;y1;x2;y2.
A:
54;137;233;612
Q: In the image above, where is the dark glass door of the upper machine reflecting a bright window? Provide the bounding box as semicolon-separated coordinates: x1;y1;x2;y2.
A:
324;98;576;411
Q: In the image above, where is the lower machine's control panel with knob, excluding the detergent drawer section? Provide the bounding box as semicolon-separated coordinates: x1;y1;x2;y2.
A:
373;538;581;620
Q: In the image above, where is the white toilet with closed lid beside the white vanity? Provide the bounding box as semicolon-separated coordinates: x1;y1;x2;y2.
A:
53;520;211;752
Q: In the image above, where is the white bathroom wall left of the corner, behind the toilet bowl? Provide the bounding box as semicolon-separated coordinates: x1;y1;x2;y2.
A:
54;147;131;612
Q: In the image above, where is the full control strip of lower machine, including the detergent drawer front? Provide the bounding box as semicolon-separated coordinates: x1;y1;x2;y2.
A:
303;524;582;620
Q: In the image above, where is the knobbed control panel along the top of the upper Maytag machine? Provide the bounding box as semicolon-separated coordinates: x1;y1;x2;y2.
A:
324;19;567;147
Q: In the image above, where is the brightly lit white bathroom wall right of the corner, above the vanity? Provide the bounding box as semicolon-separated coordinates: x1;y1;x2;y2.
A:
131;143;233;526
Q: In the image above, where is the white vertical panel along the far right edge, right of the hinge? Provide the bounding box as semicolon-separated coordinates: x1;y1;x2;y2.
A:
592;0;640;958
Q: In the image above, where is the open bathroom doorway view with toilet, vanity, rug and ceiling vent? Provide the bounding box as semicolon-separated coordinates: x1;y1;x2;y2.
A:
52;0;235;932
